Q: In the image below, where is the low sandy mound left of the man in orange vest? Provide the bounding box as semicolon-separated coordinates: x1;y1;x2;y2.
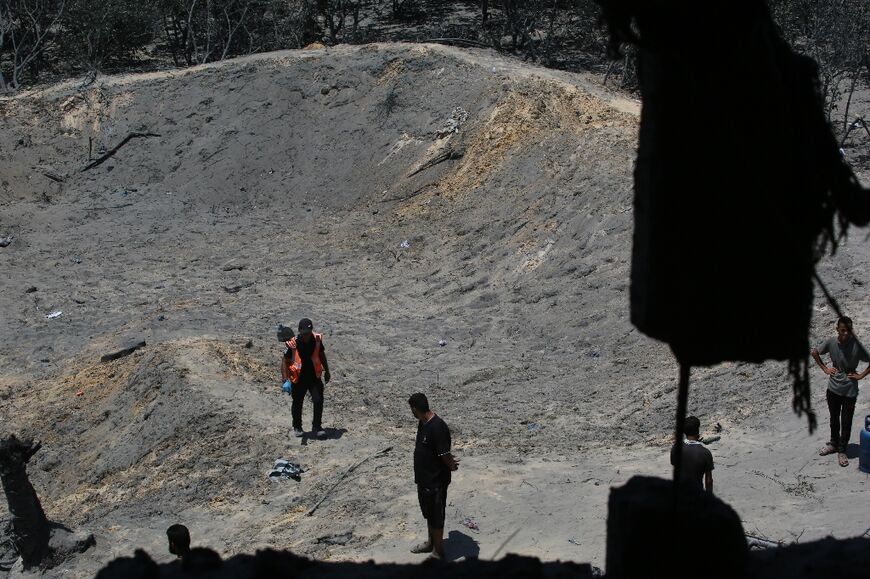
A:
12;339;285;523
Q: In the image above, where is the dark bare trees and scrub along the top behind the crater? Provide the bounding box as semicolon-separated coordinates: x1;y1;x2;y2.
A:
0;0;870;130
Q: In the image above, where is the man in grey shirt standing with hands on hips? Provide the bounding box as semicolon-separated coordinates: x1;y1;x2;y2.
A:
811;316;870;466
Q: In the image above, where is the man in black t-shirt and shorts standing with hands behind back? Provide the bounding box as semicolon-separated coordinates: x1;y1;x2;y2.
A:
408;393;459;559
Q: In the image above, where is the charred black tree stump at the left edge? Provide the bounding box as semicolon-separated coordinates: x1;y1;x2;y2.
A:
0;434;49;569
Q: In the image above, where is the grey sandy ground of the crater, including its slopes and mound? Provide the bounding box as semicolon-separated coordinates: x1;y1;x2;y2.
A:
0;45;870;577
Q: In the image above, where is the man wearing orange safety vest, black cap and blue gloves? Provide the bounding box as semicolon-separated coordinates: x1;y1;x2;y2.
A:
281;318;330;438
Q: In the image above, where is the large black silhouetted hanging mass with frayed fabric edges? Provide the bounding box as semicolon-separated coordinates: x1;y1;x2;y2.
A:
601;0;870;430
